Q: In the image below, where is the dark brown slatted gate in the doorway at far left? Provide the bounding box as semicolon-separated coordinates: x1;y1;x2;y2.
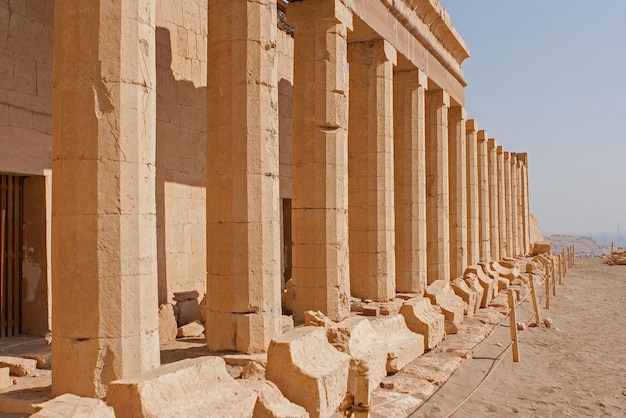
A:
0;175;24;337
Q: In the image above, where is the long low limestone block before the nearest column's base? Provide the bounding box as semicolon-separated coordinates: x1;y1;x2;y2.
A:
107;357;257;417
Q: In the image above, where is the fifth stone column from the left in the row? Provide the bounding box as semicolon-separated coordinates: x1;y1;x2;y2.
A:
393;69;427;294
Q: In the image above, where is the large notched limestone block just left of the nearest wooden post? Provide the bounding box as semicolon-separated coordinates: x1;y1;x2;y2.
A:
265;327;350;417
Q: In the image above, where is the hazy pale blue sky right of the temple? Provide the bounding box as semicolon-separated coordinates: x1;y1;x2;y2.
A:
440;0;626;235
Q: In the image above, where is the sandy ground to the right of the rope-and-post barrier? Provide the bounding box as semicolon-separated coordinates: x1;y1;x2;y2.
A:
411;258;626;417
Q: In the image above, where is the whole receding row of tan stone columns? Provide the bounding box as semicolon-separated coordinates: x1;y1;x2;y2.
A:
48;0;530;396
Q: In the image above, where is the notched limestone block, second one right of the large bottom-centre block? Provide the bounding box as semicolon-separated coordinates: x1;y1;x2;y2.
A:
372;315;424;373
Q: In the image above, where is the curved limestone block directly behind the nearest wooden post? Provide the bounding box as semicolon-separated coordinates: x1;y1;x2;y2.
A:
326;316;388;393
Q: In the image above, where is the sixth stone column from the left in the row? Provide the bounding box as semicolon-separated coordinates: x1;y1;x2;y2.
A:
426;90;450;284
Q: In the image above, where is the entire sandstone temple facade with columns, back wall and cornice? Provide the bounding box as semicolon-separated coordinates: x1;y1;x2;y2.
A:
0;0;531;404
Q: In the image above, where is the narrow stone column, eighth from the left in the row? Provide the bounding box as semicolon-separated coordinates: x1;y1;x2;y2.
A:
465;119;480;265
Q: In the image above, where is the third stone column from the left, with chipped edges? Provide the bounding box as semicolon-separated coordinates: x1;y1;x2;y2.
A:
287;0;352;322
